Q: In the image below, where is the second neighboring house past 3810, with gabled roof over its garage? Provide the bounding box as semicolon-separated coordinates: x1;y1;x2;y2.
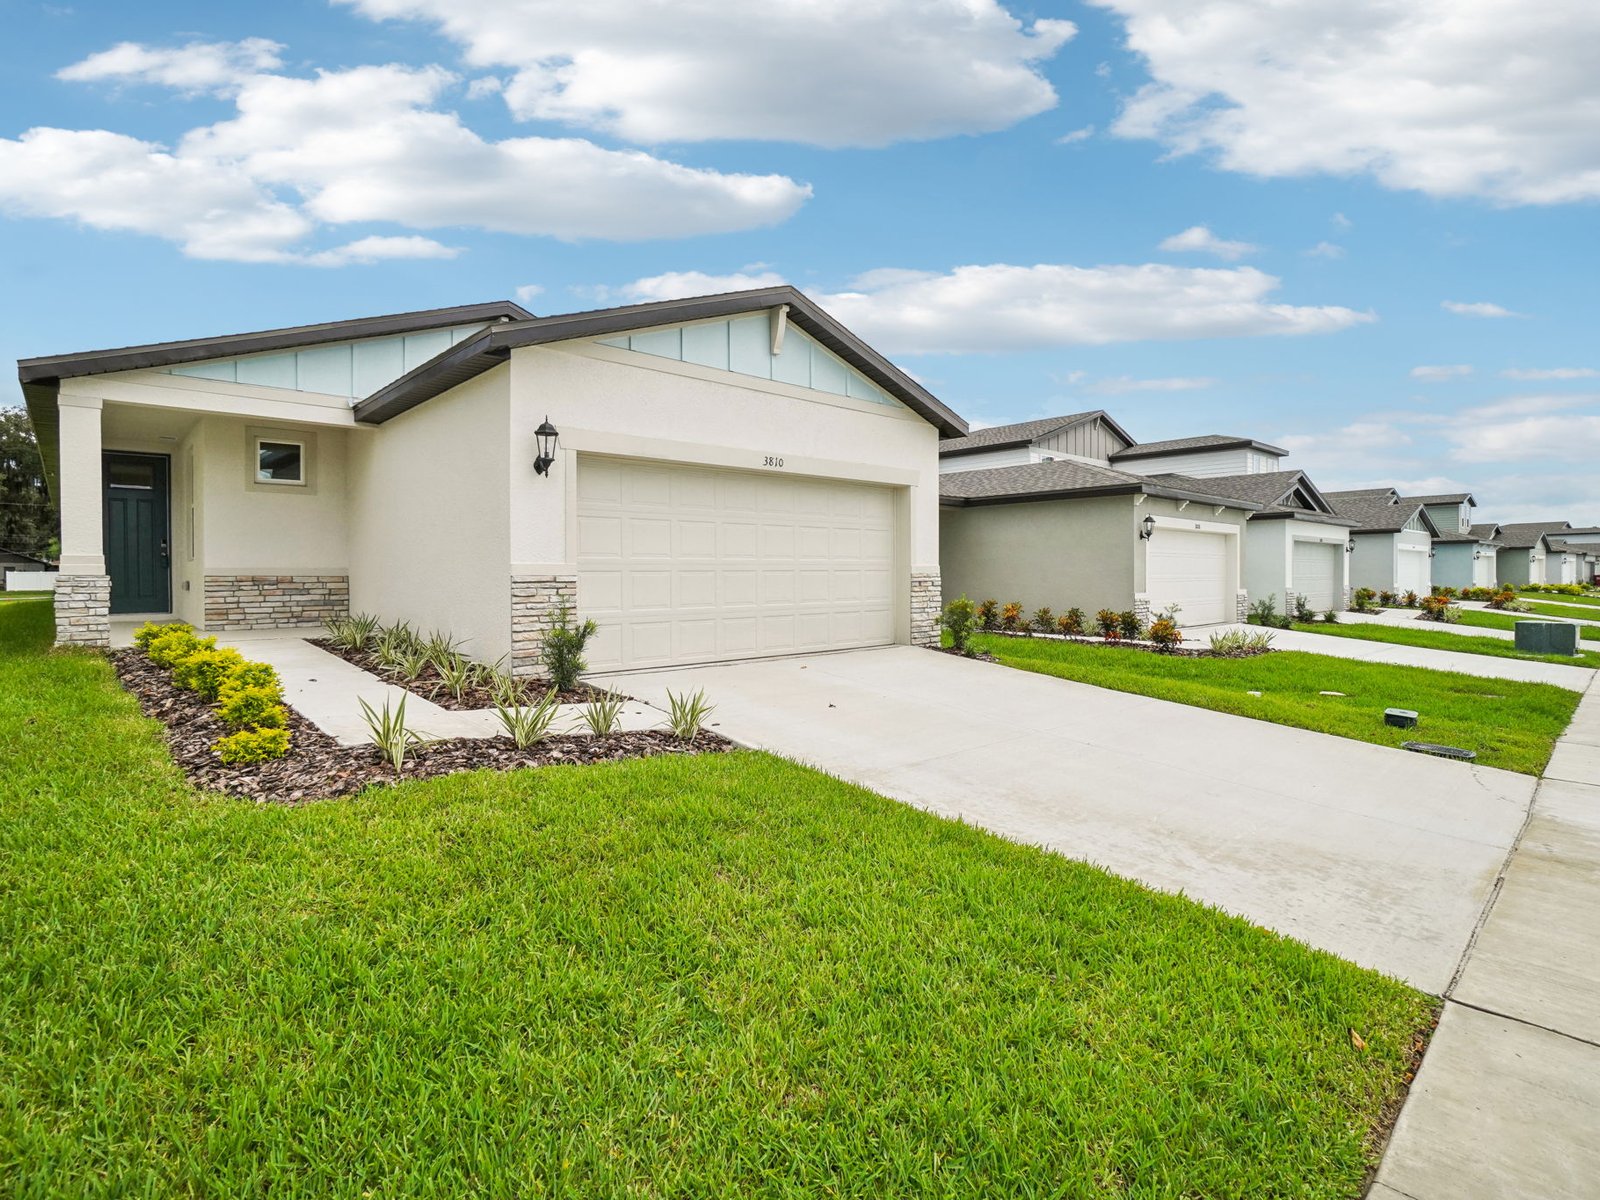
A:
1150;470;1355;613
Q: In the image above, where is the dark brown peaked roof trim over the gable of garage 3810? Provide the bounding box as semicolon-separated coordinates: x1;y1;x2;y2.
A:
355;285;966;437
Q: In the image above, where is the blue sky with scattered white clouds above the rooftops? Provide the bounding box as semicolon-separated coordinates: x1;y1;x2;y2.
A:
0;0;1600;525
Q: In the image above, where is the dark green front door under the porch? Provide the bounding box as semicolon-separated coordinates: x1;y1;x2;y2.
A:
101;453;173;613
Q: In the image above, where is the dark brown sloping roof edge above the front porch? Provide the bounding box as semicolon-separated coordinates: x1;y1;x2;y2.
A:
16;301;533;384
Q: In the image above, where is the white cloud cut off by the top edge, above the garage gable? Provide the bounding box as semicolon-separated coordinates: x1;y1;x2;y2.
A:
341;0;1077;146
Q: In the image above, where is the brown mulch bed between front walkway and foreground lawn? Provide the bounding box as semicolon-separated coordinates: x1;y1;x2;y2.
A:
110;650;733;805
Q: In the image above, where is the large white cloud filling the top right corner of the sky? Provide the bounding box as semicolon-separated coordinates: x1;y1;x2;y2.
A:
1094;0;1600;205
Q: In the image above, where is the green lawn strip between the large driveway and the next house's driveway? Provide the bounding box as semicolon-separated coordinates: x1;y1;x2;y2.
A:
973;634;1579;774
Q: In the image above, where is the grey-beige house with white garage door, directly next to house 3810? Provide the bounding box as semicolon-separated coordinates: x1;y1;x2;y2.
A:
939;459;1264;626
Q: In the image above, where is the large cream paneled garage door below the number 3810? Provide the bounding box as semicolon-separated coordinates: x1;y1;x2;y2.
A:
578;454;896;669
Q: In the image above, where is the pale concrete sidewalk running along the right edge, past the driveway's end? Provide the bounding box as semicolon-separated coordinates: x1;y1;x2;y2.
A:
1371;688;1600;1200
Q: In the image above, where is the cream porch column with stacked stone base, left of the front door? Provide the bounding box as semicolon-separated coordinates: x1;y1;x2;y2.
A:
56;395;110;646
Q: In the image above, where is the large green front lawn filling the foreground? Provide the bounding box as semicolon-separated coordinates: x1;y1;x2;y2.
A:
0;605;1432;1200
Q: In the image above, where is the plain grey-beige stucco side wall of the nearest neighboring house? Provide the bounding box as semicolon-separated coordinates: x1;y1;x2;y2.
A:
939;496;1139;614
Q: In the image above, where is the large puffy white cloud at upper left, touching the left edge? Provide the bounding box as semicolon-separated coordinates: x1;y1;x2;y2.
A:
0;56;811;262
